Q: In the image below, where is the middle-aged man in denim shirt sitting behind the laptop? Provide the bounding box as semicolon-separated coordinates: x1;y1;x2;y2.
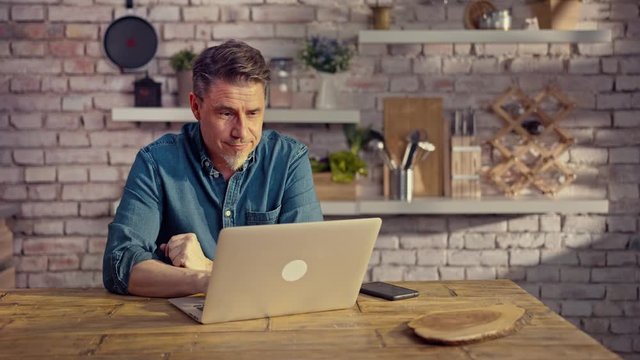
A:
103;40;322;297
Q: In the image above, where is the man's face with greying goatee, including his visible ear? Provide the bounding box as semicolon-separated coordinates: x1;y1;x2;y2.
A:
190;80;265;179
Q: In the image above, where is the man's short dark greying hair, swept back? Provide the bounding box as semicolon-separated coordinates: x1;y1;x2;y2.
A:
193;40;271;99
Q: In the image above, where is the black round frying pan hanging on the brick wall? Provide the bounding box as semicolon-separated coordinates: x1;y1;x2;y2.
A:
103;0;158;71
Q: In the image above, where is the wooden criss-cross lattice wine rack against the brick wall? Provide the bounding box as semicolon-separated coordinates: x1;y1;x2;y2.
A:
487;86;576;197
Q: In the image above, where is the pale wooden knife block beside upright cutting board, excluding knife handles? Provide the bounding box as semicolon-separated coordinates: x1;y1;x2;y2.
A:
451;136;482;198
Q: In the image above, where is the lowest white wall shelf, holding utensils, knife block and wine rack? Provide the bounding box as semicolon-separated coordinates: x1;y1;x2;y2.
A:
321;197;609;215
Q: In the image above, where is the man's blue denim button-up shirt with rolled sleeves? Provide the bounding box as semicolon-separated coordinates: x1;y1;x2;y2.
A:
102;123;322;294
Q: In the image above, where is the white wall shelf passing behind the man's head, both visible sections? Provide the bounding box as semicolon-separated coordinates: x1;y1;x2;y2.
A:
111;107;360;124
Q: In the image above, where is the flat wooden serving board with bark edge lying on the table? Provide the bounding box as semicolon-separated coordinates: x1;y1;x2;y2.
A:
409;304;527;345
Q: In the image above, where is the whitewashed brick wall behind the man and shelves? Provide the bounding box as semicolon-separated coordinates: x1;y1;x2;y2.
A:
0;0;640;359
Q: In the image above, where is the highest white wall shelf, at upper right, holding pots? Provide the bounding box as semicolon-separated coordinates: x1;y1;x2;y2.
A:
358;30;611;44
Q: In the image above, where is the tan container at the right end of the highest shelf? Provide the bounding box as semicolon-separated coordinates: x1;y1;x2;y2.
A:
531;0;582;30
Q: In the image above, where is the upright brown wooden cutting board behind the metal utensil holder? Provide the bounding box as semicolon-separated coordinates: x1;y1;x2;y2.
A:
384;97;448;196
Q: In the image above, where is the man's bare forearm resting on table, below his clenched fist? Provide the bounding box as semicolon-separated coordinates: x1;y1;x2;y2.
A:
128;260;209;297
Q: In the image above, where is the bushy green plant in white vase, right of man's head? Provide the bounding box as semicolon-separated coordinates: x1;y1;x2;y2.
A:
300;36;354;109
